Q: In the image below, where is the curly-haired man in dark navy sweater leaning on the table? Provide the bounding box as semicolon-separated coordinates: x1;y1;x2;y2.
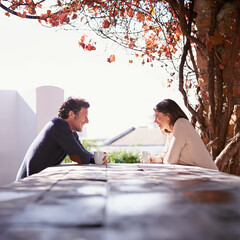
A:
16;98;108;181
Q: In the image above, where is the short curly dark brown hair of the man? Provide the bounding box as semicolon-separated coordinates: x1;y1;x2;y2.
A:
58;97;90;119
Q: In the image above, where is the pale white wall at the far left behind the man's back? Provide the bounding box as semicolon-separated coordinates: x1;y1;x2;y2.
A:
0;90;36;186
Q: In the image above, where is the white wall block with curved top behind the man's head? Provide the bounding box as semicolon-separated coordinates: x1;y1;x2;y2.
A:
36;86;64;133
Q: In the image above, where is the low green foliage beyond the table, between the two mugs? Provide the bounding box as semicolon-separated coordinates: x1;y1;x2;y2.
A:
108;149;140;163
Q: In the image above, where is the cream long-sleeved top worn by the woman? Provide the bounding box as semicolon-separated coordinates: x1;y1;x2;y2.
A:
161;118;218;170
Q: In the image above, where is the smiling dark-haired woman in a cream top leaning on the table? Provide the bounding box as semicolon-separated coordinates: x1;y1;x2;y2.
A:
150;99;218;170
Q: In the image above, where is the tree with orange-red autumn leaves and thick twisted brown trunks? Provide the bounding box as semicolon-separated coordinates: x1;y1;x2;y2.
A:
0;0;240;175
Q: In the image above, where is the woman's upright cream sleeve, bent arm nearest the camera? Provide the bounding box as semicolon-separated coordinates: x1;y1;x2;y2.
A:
163;121;186;164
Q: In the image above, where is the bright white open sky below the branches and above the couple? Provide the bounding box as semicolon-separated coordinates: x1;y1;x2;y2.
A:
0;10;185;138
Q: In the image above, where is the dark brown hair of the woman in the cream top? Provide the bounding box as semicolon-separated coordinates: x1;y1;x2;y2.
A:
153;99;188;126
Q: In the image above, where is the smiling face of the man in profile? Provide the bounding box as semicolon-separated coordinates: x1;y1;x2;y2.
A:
70;108;89;132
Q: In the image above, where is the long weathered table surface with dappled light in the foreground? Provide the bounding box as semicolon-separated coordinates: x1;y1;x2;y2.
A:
0;164;240;240
